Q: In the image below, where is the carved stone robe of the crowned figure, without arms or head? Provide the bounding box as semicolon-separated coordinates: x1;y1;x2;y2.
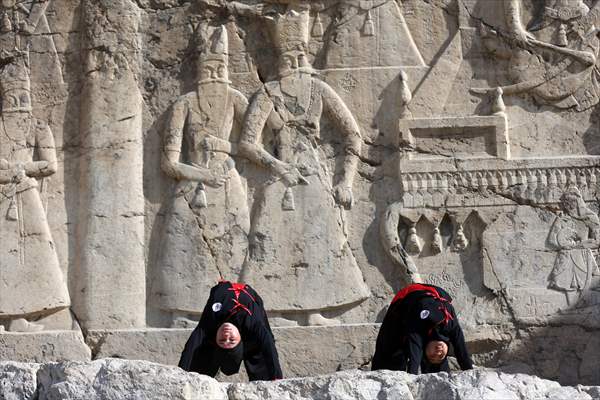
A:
242;78;370;311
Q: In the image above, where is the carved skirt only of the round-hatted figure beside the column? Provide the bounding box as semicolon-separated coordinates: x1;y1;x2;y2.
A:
154;162;249;313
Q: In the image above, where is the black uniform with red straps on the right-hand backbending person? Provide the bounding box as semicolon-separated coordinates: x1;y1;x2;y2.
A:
372;284;473;374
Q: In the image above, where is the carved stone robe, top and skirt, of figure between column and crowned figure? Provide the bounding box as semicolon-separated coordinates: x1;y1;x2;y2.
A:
151;88;250;313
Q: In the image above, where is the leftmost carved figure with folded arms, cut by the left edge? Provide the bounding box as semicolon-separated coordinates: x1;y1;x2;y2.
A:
0;55;70;331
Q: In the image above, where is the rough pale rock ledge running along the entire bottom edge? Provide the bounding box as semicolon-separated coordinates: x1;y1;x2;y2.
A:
0;359;600;400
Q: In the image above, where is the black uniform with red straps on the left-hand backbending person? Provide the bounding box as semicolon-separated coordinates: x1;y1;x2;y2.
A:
179;282;282;381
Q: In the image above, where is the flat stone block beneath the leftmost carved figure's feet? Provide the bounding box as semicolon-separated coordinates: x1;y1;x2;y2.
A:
0;331;91;362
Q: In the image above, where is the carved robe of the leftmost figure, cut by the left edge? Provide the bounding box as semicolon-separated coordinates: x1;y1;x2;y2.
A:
0;119;70;318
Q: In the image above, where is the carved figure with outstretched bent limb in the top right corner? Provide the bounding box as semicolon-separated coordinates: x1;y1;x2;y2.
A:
481;0;600;111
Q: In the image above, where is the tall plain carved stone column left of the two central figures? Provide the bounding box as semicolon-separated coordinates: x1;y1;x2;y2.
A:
73;0;146;329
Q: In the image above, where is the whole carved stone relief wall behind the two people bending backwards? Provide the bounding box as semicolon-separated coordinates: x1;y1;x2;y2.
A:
0;0;600;384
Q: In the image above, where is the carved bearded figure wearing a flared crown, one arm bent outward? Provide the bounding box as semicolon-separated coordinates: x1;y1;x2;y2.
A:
240;2;370;325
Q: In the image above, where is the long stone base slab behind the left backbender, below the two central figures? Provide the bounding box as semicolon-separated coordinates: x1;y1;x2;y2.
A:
86;324;379;377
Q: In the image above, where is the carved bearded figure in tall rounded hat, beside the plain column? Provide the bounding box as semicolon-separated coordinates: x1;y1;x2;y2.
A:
152;27;250;326
